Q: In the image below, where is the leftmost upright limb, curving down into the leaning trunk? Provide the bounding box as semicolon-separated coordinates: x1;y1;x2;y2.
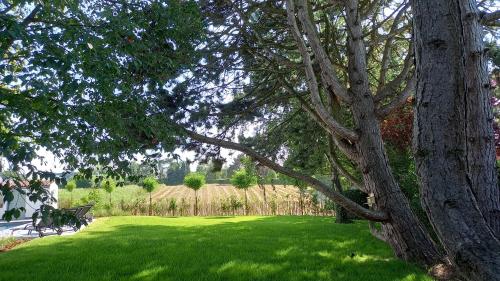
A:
286;0;358;141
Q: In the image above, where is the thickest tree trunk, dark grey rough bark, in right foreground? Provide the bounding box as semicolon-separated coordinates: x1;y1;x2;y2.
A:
412;0;500;281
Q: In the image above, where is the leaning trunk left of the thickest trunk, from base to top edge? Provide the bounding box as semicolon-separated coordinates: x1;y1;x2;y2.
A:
340;0;441;266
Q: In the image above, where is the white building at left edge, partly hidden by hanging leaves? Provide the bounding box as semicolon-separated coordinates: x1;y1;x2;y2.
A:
0;180;59;219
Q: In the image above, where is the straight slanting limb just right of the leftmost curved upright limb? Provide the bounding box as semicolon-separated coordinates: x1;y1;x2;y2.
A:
294;0;351;103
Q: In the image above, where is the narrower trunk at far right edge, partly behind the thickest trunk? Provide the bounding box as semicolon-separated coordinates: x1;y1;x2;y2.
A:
459;0;500;239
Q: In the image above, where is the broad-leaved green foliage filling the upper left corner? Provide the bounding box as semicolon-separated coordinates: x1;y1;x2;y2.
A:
0;0;204;220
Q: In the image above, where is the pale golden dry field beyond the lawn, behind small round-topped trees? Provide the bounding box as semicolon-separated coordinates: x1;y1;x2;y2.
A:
59;184;332;216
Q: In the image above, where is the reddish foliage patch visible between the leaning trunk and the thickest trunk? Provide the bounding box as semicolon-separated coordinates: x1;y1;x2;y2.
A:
380;100;413;150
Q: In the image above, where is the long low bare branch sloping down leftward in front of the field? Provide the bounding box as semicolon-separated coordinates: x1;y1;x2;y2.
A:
181;128;389;222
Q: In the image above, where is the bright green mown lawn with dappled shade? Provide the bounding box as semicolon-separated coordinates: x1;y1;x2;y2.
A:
0;217;432;281
